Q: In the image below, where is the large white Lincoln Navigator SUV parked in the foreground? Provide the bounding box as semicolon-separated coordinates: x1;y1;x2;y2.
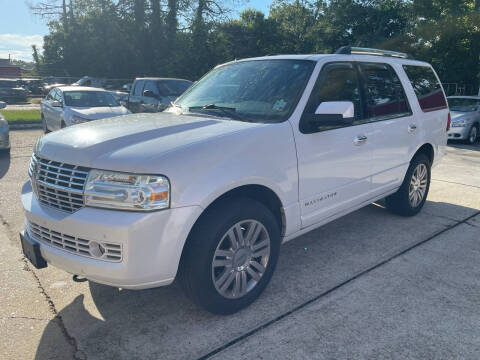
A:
21;48;449;314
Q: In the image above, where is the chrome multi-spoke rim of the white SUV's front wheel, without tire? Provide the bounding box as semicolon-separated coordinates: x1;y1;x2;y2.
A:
212;220;270;299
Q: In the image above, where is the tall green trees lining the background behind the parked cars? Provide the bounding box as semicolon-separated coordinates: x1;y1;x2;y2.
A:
35;0;480;88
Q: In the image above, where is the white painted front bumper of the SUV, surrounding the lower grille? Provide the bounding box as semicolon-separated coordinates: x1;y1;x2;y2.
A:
22;181;201;289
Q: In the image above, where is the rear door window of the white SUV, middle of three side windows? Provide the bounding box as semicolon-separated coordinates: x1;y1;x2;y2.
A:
359;63;411;121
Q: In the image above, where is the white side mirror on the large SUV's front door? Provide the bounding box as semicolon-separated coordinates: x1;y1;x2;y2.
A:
312;101;355;126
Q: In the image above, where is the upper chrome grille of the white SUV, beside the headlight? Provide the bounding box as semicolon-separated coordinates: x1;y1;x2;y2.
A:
28;155;89;213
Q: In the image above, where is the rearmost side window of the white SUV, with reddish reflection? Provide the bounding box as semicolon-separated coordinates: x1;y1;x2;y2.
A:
403;65;447;111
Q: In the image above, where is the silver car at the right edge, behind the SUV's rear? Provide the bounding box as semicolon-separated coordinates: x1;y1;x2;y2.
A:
447;96;480;144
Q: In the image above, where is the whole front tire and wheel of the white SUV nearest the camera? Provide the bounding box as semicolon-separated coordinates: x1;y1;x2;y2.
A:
180;198;280;315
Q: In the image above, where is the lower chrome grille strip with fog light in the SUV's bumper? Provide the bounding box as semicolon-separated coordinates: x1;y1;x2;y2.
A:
28;222;122;262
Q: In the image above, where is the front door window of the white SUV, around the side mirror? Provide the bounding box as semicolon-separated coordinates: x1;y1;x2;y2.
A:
301;63;363;133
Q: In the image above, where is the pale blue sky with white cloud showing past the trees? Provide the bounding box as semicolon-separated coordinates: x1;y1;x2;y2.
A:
0;0;272;61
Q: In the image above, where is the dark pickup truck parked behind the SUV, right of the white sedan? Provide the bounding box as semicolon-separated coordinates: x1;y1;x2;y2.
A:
127;78;193;113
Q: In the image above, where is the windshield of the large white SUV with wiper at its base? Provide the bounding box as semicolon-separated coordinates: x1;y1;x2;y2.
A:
175;60;315;122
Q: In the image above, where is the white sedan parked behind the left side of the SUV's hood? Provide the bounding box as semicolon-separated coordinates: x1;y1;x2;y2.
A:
41;86;130;133
